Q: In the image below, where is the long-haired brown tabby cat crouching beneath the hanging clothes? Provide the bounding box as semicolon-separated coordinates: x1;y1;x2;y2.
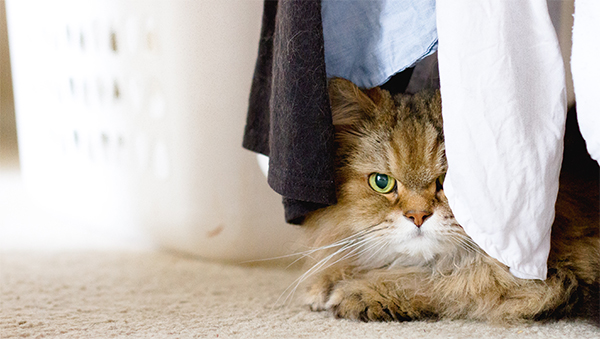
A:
305;79;600;322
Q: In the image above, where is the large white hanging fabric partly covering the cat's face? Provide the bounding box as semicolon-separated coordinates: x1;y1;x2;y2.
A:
436;0;568;279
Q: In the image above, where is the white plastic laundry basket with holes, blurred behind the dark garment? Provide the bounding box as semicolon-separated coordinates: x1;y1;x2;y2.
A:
6;0;296;261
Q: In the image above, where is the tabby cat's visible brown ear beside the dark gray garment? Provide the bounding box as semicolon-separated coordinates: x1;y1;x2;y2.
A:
329;78;390;126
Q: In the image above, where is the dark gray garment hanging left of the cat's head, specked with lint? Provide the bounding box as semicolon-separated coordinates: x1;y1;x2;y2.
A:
243;0;337;224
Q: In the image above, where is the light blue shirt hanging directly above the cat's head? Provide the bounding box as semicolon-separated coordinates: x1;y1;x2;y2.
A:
321;0;438;88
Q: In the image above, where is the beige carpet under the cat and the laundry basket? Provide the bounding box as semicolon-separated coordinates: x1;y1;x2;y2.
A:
0;251;600;338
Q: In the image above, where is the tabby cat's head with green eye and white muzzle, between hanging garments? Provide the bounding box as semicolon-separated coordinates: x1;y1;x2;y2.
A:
312;79;465;266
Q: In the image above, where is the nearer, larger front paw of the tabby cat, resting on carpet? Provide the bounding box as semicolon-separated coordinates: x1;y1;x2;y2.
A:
325;280;411;321
